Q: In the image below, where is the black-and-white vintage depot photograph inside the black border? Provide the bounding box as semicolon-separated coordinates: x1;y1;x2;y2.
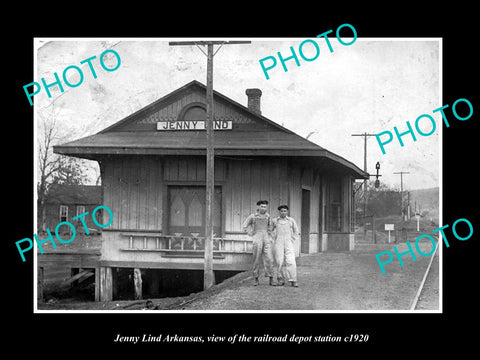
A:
31;37;440;313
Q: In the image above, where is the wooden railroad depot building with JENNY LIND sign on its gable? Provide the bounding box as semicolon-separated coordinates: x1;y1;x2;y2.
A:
54;81;368;301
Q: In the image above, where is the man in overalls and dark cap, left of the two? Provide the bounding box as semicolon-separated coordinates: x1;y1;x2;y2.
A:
242;200;275;286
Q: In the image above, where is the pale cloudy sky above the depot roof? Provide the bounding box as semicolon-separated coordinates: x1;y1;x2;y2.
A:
33;37;443;190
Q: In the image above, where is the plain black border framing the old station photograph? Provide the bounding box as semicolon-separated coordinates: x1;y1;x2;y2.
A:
8;7;480;357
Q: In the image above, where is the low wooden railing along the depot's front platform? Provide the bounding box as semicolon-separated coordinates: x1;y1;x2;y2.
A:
121;232;252;254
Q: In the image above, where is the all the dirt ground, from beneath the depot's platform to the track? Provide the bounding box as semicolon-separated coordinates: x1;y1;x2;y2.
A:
38;243;439;311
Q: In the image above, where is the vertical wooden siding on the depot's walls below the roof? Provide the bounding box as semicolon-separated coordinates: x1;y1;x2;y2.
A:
102;156;352;262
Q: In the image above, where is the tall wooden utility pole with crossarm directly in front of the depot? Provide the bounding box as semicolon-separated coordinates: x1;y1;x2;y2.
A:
168;41;251;290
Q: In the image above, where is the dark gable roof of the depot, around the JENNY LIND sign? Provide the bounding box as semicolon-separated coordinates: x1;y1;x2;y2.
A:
54;80;368;178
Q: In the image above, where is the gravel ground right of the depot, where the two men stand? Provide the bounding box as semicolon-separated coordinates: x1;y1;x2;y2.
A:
182;244;438;310
